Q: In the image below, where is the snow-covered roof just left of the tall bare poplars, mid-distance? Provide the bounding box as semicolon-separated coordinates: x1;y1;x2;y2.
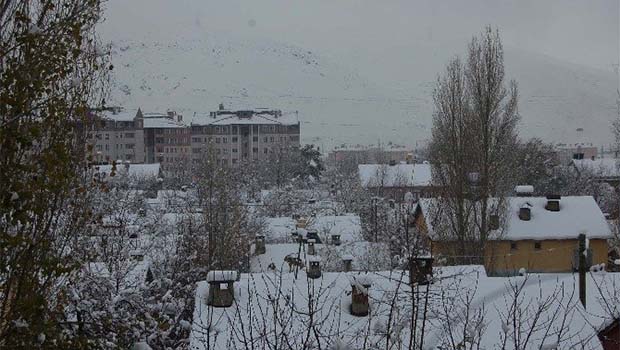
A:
358;163;432;187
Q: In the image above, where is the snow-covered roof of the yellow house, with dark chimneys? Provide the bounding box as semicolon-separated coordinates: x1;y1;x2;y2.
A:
418;196;611;240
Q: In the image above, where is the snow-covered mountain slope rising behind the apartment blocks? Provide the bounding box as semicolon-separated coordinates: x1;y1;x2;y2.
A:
104;2;617;148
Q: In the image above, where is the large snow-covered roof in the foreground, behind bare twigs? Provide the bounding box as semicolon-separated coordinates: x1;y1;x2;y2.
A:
190;266;620;350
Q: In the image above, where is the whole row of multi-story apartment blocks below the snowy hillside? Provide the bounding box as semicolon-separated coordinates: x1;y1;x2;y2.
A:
86;105;300;172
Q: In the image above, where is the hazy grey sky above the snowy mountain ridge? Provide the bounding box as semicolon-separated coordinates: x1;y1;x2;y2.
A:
102;0;620;70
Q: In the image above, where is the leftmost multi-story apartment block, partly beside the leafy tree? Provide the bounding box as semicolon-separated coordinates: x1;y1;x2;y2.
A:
86;107;145;164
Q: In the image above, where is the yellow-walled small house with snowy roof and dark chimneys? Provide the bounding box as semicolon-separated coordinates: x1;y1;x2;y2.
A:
416;195;611;276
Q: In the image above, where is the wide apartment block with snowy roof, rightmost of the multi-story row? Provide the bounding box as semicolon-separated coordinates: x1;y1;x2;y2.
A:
191;105;300;165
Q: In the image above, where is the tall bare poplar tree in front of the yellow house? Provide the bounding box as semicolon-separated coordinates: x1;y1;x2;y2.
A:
430;28;519;255
